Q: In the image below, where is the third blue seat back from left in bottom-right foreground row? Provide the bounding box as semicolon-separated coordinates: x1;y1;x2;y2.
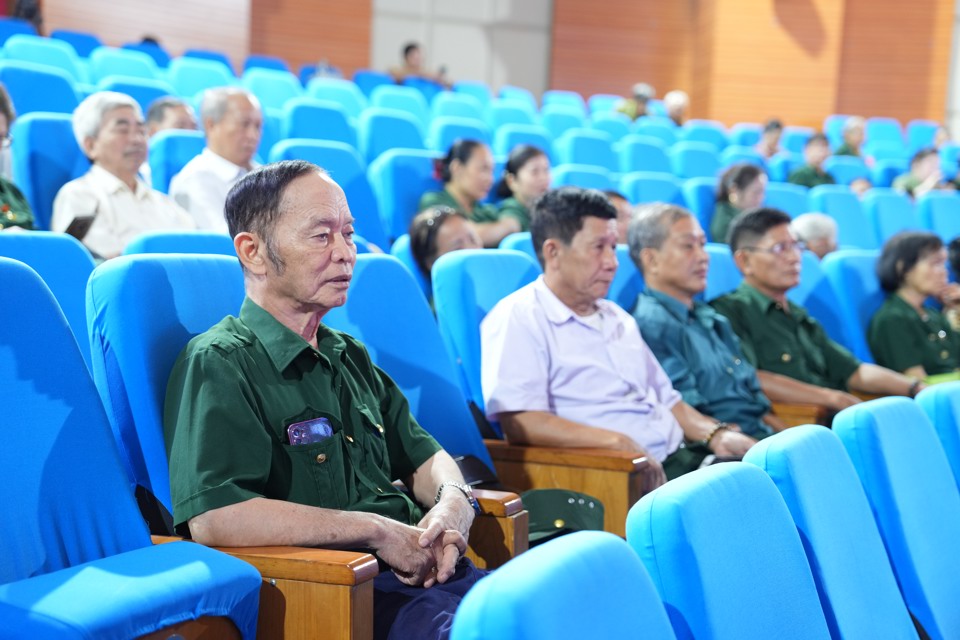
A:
744;425;917;640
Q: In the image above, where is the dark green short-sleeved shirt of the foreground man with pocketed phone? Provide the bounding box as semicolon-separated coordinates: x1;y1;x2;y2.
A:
164;299;440;533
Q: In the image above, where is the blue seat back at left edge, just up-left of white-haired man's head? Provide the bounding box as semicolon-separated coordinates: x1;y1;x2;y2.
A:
0;60;80;116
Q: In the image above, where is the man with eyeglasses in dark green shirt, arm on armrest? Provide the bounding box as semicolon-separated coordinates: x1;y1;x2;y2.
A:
711;208;923;411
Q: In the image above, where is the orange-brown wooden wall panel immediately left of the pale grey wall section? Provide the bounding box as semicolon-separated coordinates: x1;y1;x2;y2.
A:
250;0;373;77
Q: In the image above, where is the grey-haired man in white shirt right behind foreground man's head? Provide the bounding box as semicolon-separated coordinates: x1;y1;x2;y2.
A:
170;87;263;233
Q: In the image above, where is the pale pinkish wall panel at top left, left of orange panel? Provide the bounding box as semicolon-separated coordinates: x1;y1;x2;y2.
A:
43;0;250;72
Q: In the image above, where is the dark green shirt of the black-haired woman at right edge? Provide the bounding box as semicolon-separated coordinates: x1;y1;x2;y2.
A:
867;294;960;376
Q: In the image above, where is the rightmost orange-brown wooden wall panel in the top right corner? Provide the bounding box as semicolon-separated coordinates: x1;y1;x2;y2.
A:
837;0;954;122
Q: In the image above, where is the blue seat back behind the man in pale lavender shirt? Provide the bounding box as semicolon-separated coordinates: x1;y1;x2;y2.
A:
433;249;540;409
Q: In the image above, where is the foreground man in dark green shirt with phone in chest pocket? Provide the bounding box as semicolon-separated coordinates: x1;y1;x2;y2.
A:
164;161;482;638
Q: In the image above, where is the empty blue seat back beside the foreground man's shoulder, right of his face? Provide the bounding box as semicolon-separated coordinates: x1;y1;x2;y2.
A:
323;253;493;472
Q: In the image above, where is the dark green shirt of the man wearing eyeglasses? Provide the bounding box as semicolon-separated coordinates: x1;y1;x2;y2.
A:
710;282;860;390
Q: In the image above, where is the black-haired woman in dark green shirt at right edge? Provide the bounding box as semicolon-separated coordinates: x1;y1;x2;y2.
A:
867;231;960;379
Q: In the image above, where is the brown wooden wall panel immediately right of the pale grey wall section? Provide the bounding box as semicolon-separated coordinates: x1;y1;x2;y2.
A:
550;0;697;110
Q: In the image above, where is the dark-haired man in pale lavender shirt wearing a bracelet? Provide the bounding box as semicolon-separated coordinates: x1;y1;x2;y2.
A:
480;187;755;486
